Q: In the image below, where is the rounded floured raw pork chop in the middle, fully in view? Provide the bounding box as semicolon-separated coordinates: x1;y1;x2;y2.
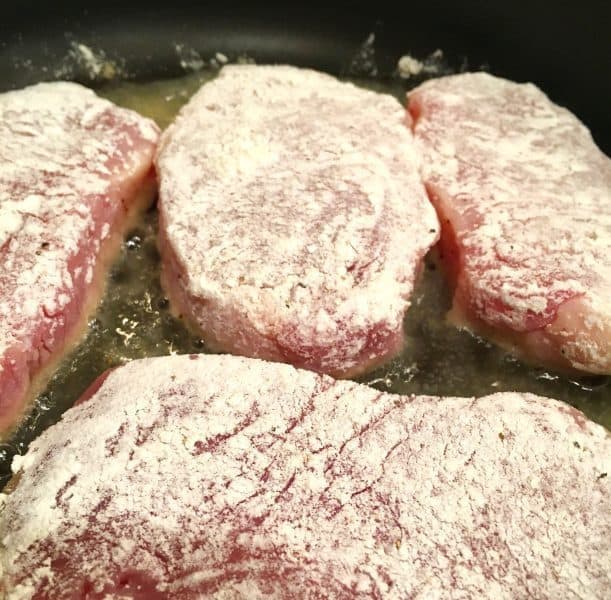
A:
157;66;439;376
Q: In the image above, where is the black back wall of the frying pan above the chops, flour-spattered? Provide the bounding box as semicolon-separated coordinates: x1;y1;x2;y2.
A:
0;0;611;487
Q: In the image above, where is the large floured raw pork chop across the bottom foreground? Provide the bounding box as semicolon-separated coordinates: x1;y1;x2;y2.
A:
0;355;611;600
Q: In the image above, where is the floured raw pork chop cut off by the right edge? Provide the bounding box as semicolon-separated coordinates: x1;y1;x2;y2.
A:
409;73;611;374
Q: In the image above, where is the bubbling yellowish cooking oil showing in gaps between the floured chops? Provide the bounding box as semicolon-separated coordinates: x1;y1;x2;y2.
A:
0;71;611;487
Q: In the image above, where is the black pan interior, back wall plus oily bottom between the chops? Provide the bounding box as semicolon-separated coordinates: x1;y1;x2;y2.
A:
0;2;611;485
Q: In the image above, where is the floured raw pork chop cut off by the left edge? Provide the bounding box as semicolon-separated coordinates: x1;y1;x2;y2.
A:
0;83;158;430
